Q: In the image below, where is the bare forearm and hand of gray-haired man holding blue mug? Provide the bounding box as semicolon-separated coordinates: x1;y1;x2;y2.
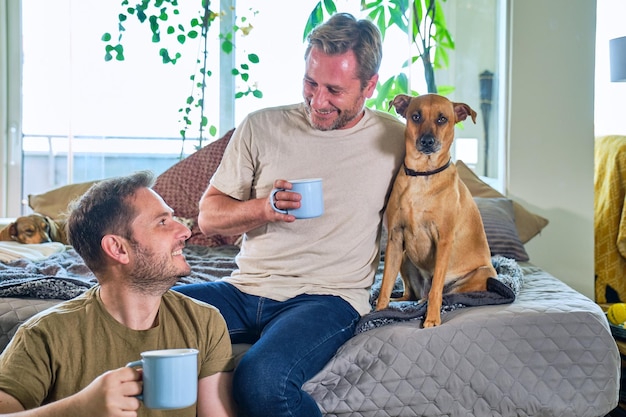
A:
198;180;301;236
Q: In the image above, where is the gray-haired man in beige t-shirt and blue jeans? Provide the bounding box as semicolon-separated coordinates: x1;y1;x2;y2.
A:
177;13;404;417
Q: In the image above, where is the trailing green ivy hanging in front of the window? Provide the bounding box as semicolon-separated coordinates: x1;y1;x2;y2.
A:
102;0;263;153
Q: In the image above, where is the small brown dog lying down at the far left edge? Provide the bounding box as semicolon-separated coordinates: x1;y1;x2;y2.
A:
0;213;67;245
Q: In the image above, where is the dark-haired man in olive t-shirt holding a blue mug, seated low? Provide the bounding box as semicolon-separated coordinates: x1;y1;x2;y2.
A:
0;172;235;417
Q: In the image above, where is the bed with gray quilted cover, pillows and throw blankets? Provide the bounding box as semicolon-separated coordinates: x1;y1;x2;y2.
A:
0;129;620;417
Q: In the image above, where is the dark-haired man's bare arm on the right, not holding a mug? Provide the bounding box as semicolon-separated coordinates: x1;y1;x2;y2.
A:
197;372;237;417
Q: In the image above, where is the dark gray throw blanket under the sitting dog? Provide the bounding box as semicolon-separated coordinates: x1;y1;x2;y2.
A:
355;255;524;334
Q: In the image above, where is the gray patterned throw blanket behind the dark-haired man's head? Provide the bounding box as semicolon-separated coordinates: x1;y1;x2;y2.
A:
0;246;239;300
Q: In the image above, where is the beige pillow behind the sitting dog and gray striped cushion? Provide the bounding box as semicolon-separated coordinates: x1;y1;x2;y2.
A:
455;160;548;243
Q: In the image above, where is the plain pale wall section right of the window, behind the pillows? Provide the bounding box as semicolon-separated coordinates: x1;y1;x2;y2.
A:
506;0;596;299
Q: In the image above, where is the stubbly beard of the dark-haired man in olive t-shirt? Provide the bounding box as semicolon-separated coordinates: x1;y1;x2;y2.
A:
128;242;191;295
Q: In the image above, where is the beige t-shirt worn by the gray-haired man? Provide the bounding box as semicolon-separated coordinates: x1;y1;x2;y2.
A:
211;104;405;314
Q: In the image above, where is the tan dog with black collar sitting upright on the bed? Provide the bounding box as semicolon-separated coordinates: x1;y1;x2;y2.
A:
376;94;496;327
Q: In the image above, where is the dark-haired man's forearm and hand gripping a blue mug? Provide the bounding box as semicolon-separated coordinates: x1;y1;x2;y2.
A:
0;367;141;417
